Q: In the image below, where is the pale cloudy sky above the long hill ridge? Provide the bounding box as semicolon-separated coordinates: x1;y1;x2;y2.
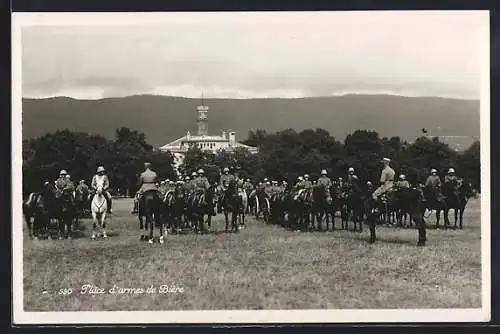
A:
21;12;487;99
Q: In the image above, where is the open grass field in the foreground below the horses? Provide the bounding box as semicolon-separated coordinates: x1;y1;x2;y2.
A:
23;199;481;311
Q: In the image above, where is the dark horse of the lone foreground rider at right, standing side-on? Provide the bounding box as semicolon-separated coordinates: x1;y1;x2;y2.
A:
363;188;427;246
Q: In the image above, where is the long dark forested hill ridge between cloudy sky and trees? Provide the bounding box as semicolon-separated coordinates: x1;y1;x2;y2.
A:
23;95;480;146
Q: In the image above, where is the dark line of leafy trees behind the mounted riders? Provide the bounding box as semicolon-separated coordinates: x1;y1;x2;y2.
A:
23;128;480;194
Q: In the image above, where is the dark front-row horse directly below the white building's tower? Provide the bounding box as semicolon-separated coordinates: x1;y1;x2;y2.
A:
193;185;217;233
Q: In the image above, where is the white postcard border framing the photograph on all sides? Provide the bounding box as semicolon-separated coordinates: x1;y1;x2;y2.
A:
11;11;491;325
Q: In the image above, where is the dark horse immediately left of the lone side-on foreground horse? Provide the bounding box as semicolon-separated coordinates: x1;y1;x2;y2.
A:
340;183;363;232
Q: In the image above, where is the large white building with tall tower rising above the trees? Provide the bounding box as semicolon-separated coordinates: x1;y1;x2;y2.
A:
160;104;258;174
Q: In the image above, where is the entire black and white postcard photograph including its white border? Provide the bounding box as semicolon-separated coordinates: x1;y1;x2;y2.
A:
12;11;491;324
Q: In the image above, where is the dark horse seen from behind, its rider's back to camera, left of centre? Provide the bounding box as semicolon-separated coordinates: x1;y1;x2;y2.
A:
139;189;165;244
